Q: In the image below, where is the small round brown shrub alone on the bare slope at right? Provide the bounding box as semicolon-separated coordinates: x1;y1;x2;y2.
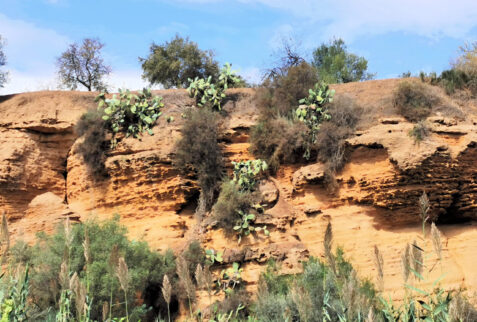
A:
393;81;439;122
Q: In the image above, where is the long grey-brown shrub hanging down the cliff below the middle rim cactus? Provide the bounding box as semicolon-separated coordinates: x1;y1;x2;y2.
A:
174;109;224;209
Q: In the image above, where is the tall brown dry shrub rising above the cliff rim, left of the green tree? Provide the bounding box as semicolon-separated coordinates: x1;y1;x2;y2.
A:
256;62;318;119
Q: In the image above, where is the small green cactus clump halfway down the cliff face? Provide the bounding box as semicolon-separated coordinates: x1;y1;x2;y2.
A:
232;159;268;191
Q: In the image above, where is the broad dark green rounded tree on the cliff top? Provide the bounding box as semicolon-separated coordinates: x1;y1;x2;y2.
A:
139;35;219;88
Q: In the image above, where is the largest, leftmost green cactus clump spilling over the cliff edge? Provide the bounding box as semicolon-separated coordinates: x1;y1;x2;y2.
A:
96;89;164;148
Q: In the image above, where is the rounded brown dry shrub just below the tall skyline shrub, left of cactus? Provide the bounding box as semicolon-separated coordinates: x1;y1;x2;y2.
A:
250;117;307;171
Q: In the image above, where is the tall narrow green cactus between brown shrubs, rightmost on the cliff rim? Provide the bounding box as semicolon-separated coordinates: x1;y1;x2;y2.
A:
295;82;335;159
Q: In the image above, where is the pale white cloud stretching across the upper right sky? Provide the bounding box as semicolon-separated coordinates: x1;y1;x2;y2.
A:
182;0;477;40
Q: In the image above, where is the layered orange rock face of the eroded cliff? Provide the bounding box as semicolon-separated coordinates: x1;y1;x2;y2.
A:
0;80;477;306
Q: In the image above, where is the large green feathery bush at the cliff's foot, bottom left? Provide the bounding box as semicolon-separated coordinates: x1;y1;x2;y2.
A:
11;218;175;320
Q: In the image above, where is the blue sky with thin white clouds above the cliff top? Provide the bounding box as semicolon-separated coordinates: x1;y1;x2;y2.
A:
0;0;477;94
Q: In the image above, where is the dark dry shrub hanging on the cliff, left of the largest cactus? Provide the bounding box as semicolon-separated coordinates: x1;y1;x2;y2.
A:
76;109;109;179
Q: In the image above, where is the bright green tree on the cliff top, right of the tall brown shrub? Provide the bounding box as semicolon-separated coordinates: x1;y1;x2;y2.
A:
312;39;375;83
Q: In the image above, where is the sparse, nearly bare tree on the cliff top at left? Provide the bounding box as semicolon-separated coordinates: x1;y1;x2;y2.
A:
57;38;111;91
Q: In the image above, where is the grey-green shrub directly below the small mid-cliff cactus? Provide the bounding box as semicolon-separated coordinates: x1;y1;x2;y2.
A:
212;181;259;233
